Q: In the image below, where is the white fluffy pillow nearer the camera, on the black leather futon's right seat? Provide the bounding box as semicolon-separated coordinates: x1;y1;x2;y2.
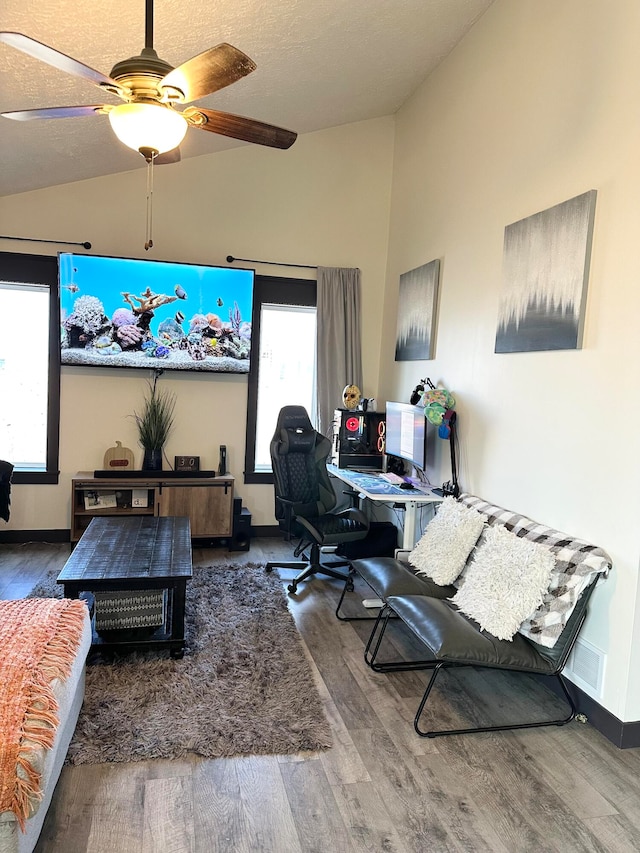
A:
452;527;555;640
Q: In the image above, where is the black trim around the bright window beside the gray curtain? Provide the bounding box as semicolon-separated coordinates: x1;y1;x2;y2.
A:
244;275;317;484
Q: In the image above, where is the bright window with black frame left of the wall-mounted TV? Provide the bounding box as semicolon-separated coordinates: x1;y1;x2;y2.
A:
0;252;60;483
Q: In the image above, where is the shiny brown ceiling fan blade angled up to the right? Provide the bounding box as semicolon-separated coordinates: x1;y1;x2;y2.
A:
160;42;256;103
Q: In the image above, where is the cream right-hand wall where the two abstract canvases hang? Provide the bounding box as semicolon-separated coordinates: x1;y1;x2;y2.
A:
381;0;640;721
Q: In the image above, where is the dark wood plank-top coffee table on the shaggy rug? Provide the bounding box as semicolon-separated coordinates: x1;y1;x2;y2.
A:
57;516;193;658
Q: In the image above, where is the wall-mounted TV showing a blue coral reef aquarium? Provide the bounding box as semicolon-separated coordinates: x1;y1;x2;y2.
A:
58;252;254;373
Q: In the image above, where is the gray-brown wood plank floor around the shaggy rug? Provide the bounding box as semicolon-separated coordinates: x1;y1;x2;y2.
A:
0;539;640;853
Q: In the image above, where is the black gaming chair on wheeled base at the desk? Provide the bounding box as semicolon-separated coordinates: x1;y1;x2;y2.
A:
266;406;369;593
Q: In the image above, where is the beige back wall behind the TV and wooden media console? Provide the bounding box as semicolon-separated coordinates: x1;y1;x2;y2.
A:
0;118;393;530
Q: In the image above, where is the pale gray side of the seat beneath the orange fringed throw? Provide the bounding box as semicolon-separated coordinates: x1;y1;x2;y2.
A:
0;610;91;853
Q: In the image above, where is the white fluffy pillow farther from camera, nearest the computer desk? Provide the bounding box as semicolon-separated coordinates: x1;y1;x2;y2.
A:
408;498;487;586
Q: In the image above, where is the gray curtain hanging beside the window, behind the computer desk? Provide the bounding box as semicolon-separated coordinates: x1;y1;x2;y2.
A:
316;267;364;437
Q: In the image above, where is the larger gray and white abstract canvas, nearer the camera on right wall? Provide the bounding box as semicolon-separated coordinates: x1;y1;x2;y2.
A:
495;190;596;353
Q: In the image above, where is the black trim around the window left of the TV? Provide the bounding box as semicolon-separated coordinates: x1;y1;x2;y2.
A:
0;252;60;485
